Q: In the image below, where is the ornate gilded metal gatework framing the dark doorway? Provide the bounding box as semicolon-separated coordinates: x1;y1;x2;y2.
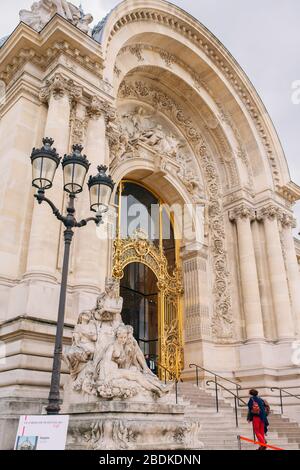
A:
113;231;184;378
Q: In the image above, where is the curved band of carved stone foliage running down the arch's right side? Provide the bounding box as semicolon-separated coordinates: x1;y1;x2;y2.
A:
119;81;233;341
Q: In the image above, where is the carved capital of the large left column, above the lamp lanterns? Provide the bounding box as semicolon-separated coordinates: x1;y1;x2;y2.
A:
40;73;82;103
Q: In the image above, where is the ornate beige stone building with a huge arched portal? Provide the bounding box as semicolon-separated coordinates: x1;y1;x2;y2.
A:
0;0;300;430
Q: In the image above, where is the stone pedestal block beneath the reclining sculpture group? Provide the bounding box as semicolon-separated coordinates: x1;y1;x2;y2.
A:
66;399;203;450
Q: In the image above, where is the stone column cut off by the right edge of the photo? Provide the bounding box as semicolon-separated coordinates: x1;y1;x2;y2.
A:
281;212;300;337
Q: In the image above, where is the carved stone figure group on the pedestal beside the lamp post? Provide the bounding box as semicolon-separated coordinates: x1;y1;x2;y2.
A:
63;280;170;400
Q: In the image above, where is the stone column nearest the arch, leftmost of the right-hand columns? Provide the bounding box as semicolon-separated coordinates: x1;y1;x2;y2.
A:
229;204;264;341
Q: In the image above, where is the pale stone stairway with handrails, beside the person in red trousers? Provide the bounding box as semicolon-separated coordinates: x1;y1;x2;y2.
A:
178;382;300;450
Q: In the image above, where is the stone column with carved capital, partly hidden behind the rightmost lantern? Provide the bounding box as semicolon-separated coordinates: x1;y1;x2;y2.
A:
75;97;108;291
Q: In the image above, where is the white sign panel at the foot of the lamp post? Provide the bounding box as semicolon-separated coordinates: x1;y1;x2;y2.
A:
15;415;69;450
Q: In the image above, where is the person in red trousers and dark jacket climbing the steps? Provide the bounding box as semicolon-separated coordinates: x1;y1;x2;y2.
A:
247;389;269;450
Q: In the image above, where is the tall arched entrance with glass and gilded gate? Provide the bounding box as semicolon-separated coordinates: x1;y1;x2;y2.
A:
113;181;183;377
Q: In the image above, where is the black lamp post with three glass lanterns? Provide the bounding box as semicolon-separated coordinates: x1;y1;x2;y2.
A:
31;137;114;414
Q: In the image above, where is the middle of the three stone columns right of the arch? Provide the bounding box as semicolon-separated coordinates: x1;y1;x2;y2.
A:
257;204;294;340
